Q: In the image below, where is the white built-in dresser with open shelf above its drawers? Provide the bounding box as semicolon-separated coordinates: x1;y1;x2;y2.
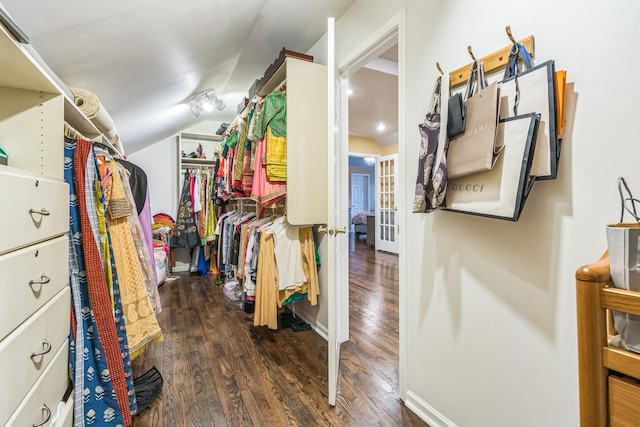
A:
0;17;73;427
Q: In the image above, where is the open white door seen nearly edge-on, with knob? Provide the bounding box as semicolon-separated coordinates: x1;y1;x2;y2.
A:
323;18;349;406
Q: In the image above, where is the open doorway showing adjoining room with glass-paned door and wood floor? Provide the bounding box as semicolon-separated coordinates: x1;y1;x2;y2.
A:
341;32;404;400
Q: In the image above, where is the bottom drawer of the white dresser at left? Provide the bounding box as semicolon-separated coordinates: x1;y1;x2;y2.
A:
7;341;69;427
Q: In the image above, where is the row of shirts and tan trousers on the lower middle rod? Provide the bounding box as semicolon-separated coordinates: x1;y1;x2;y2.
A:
216;211;320;329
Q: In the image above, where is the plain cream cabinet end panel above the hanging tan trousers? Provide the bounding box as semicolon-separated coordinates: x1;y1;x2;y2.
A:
286;58;328;225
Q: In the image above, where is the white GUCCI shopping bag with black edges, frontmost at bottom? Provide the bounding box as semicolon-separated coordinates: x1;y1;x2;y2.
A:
446;114;540;221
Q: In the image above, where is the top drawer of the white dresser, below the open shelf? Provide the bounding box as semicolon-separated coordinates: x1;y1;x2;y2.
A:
0;170;69;254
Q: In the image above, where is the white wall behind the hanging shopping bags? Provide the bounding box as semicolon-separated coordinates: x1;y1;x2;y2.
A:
310;0;640;427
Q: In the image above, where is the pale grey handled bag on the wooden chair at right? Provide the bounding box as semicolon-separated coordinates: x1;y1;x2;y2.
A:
606;178;640;353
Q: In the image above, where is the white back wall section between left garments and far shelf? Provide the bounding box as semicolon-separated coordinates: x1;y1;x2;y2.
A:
127;136;179;220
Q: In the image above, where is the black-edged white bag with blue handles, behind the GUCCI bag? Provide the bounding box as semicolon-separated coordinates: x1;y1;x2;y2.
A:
500;44;560;180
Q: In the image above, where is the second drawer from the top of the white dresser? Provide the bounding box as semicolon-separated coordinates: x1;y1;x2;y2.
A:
0;236;69;340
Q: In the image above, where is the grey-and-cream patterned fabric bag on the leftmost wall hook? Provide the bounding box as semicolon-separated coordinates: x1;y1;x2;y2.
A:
413;75;449;213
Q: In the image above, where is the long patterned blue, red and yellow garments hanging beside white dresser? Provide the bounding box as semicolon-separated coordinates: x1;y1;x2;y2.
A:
64;136;162;426
